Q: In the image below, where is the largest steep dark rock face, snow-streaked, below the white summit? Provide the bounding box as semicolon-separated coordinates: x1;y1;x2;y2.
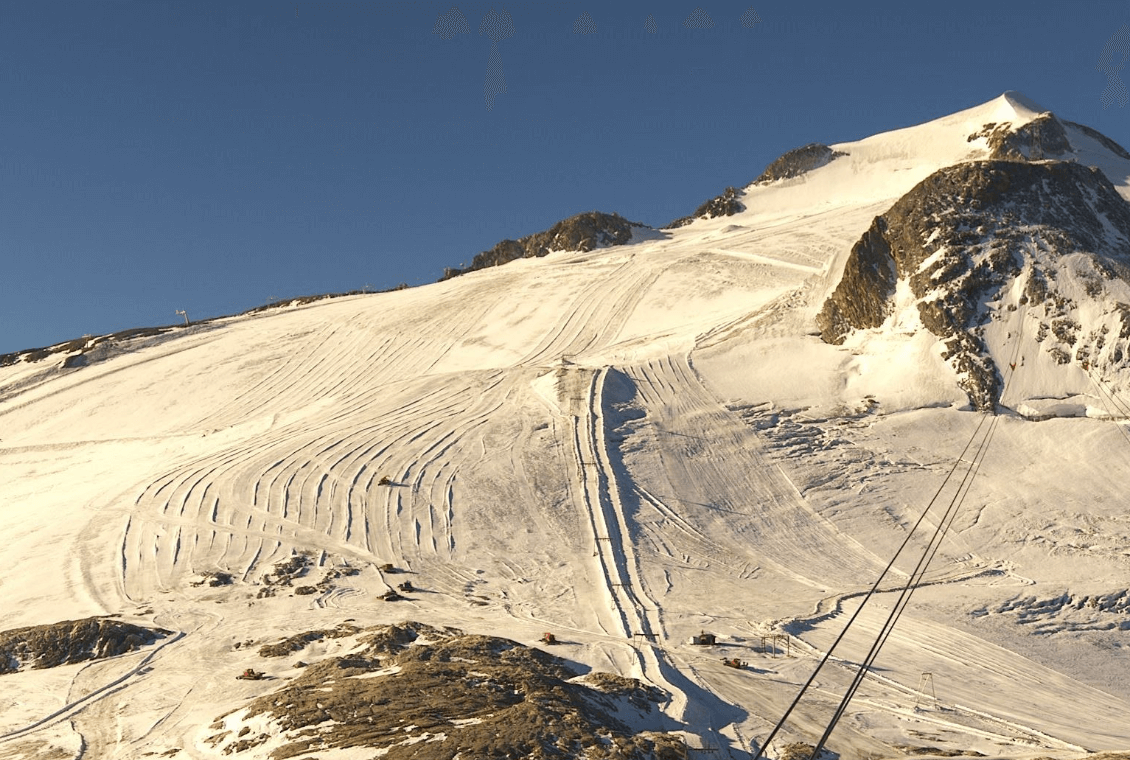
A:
817;158;1130;409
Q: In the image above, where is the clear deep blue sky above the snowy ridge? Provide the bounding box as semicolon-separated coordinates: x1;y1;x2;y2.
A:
0;0;1130;353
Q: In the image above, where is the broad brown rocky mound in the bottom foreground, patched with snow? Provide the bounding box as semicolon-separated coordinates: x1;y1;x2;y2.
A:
201;622;684;760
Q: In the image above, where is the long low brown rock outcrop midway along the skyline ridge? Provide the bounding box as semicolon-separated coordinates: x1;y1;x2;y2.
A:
442;211;647;280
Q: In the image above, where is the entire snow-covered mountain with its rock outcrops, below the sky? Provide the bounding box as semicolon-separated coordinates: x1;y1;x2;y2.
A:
0;93;1130;760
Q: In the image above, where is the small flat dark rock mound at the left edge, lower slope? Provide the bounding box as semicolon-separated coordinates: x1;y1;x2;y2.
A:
0;618;170;674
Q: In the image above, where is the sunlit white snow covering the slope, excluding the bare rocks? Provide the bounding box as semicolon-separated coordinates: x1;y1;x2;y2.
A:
0;94;1130;758
